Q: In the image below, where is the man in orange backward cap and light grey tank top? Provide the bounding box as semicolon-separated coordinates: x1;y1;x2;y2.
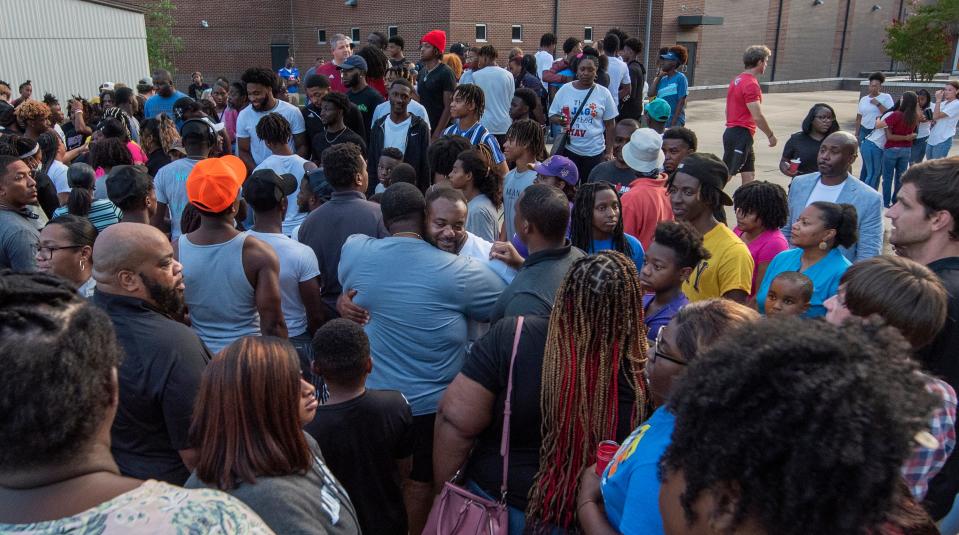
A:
175;156;287;353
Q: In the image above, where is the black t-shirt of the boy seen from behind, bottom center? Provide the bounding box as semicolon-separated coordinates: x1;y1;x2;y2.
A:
306;390;413;535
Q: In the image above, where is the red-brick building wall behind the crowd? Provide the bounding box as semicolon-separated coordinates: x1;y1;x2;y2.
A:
130;0;903;88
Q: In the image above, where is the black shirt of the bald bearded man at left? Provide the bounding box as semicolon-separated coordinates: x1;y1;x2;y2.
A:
93;289;212;485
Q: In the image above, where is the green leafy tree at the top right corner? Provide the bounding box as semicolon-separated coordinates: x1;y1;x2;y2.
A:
883;0;959;81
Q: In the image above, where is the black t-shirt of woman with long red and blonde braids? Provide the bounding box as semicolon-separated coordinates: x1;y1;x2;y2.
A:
462;316;634;510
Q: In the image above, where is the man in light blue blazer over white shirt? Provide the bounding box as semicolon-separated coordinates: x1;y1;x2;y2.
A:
782;131;882;262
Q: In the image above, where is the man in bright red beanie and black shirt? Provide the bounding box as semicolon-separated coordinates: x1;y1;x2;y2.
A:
416;30;456;140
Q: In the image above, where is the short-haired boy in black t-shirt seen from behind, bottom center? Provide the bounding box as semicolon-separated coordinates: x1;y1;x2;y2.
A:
306;318;413;535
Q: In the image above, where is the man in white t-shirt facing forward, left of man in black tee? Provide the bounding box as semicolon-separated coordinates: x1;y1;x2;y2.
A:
236;67;309;171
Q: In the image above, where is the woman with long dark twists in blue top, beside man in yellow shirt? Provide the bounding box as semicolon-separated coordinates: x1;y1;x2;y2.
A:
569;182;643;271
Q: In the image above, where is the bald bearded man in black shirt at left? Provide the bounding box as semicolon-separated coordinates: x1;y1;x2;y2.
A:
93;223;212;485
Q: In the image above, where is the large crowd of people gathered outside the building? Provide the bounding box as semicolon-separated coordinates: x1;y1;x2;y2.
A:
0;29;959;535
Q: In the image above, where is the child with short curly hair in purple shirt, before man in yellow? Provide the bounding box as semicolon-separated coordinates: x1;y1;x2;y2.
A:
639;221;709;343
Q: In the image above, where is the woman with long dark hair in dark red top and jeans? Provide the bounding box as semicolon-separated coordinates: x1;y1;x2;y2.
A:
876;91;922;208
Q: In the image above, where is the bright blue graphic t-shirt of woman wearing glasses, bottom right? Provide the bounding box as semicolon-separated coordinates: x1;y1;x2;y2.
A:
600;406;676;535
